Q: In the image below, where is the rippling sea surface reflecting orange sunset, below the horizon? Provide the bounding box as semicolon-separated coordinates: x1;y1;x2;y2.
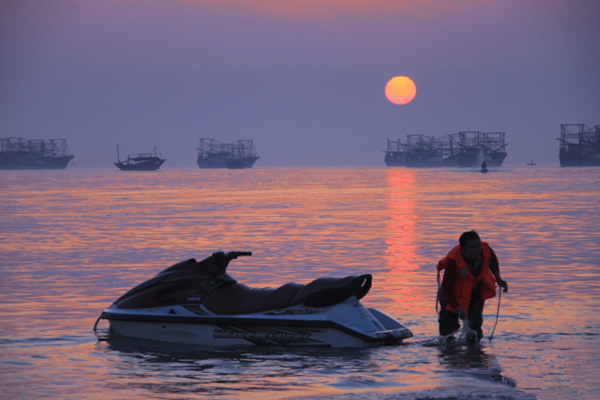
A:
0;165;600;399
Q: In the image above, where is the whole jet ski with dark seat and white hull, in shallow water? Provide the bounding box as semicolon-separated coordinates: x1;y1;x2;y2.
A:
94;251;413;347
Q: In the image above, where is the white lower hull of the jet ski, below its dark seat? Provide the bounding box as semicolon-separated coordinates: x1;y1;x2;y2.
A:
101;296;412;347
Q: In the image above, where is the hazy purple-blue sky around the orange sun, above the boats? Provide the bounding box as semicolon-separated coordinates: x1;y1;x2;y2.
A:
0;0;600;168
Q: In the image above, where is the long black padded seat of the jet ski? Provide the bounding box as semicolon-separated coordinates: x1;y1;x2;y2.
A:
203;274;372;314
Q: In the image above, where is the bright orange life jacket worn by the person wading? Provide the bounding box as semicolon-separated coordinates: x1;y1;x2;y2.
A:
437;242;496;313
